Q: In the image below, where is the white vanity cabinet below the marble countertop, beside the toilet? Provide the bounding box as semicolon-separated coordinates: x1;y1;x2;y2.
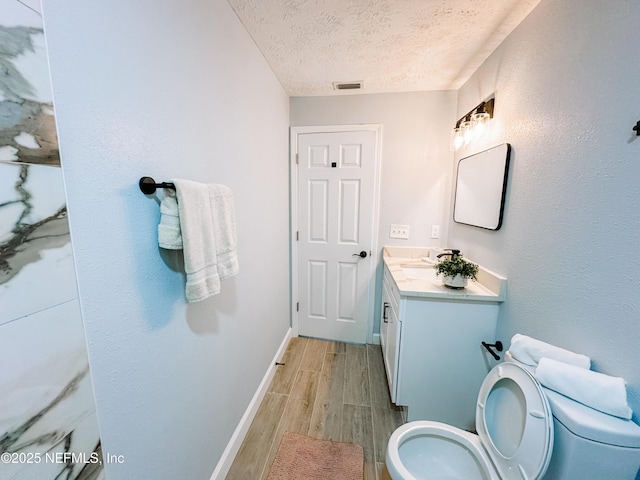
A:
380;264;501;430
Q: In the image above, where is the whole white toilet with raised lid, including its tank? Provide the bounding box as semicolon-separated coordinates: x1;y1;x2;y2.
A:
387;355;640;480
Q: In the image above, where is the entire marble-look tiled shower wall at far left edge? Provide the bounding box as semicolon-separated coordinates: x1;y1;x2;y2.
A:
0;0;105;480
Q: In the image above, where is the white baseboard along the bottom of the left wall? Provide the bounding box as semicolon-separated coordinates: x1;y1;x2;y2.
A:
210;328;292;480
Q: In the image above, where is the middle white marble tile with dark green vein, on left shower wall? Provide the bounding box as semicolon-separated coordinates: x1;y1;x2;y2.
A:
0;163;78;325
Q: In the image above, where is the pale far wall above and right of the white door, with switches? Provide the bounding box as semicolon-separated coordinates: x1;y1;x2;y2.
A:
290;91;456;332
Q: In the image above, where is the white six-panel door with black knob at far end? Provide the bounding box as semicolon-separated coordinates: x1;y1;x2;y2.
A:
294;126;377;343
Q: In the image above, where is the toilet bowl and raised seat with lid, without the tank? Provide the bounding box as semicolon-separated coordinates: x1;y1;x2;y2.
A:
386;362;553;480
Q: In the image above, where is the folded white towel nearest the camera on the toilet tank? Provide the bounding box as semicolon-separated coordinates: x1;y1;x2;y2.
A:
535;358;633;420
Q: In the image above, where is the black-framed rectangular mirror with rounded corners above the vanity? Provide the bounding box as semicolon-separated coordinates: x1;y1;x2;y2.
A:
453;143;511;230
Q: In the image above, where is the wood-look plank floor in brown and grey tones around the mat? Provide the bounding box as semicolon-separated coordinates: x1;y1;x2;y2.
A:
226;337;403;480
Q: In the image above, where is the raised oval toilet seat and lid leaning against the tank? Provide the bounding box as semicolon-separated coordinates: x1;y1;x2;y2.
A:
476;362;553;480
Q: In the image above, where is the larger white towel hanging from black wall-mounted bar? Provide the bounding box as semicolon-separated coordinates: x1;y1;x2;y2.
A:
172;179;239;303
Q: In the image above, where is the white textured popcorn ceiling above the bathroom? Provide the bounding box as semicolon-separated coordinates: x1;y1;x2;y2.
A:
228;0;540;96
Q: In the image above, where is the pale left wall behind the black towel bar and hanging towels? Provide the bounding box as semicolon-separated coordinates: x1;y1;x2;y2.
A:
44;0;289;480
